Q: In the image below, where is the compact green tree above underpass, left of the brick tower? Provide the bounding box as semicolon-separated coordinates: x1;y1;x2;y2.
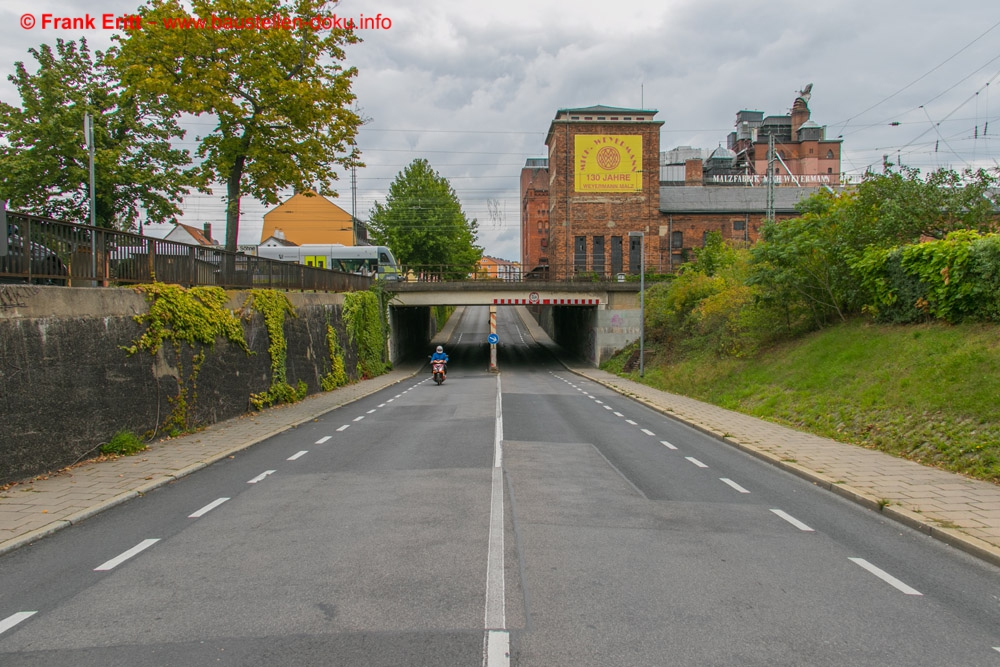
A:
368;159;483;279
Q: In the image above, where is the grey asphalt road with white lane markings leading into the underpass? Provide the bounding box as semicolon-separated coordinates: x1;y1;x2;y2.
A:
0;308;1000;667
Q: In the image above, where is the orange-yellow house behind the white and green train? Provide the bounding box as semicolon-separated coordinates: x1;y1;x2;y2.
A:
260;190;367;245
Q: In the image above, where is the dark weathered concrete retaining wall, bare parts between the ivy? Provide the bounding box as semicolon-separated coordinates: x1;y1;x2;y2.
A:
0;285;380;483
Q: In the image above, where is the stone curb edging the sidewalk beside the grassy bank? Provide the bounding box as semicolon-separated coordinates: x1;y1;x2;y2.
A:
556;368;1000;567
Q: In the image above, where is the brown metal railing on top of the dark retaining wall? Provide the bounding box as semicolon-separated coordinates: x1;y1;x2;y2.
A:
0;212;372;292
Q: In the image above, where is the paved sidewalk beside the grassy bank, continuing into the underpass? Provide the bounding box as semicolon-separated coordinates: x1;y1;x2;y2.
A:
501;307;1000;566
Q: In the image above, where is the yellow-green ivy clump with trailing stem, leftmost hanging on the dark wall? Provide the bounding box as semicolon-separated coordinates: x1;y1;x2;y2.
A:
123;283;251;434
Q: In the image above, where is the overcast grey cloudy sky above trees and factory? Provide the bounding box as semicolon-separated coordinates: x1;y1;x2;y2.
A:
0;0;1000;260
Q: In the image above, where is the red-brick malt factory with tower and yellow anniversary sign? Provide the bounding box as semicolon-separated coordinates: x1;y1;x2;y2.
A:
521;85;841;278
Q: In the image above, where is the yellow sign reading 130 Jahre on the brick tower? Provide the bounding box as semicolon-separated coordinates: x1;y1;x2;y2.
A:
573;134;642;192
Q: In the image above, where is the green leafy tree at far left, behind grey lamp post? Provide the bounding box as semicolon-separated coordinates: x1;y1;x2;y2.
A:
0;39;191;229
